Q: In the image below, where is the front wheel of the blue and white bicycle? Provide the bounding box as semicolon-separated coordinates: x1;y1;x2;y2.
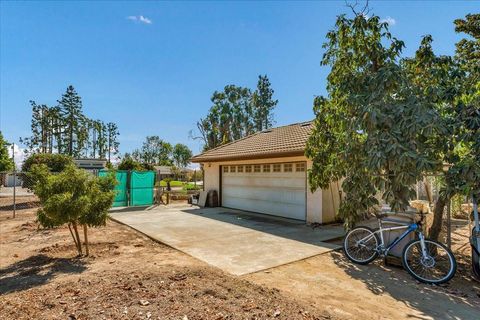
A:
402;239;457;284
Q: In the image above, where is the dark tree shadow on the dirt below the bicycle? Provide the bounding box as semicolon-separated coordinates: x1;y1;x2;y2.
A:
331;252;480;320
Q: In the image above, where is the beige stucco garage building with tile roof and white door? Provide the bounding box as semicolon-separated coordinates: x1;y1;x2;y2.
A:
192;121;340;223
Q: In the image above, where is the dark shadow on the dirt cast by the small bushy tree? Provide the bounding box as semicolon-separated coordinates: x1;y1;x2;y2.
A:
0;254;87;295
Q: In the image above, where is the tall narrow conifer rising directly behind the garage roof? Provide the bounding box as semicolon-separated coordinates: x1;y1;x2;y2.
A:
252;75;278;131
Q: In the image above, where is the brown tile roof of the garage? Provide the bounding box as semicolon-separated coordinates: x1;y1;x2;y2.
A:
192;121;312;162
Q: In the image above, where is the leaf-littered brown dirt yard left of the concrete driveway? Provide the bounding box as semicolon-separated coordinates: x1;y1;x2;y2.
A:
0;200;335;320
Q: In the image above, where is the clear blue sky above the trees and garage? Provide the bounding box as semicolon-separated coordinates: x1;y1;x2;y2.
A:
0;1;480;159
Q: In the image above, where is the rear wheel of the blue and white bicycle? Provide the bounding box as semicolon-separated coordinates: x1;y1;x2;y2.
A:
343;227;380;264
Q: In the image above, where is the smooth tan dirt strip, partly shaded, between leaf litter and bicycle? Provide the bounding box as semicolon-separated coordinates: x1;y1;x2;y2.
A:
245;220;480;320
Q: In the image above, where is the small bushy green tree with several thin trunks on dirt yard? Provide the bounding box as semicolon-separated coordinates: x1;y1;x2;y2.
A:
32;165;116;256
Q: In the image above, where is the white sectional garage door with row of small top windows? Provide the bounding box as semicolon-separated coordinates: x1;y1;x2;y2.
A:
221;162;306;220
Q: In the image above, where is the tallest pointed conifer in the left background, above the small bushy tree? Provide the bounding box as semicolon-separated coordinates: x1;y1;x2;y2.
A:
58;85;87;157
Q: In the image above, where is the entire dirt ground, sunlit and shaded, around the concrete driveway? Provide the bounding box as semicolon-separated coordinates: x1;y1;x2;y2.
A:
0;198;480;320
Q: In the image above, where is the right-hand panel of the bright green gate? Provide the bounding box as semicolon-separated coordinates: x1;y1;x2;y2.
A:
130;171;155;206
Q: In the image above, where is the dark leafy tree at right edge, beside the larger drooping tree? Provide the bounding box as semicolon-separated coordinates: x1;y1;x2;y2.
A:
404;14;480;239
